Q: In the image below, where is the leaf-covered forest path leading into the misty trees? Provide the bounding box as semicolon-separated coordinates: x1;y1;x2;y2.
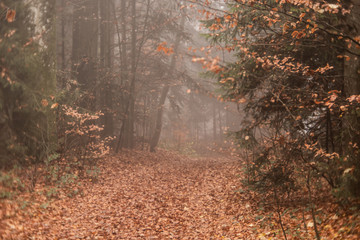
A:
4;150;254;239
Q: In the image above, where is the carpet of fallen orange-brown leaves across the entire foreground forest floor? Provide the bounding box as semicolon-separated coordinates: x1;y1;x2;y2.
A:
0;150;359;240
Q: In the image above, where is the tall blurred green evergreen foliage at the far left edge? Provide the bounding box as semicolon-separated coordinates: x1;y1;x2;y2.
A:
0;1;55;168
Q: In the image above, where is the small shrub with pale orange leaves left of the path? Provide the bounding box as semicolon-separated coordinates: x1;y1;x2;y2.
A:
38;103;108;198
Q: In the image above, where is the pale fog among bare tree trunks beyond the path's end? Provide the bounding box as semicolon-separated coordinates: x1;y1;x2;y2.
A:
56;0;241;151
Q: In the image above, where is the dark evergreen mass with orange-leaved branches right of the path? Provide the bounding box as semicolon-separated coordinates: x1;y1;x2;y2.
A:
200;0;360;203
